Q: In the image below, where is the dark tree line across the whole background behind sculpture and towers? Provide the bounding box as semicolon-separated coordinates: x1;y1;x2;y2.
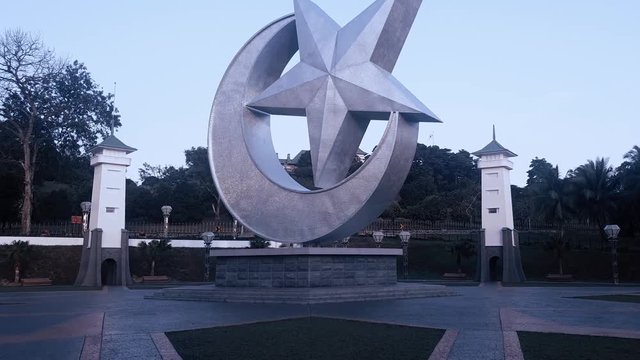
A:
0;30;640;240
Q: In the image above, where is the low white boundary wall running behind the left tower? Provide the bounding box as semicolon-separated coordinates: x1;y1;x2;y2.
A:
0;236;249;248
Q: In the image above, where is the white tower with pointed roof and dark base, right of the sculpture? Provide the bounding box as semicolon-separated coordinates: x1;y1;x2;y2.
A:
473;126;525;282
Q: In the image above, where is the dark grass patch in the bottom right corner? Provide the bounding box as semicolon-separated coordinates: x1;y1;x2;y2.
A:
518;331;640;360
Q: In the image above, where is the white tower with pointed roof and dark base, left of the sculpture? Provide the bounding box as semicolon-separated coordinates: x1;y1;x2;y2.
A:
76;129;136;286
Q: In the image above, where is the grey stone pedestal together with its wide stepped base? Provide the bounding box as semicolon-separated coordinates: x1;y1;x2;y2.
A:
145;248;456;304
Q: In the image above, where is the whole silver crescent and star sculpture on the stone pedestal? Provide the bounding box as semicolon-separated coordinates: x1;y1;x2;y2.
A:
208;0;439;243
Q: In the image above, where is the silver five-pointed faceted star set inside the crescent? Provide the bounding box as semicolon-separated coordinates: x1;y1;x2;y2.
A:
247;0;440;188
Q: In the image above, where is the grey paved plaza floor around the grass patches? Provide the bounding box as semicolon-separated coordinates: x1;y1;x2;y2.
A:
0;284;640;359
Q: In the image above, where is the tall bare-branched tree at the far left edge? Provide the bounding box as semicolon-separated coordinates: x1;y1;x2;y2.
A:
0;30;61;234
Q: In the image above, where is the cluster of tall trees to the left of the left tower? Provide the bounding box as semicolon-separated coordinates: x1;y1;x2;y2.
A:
0;30;120;234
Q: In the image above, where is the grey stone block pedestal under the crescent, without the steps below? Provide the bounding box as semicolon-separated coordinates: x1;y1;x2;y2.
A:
211;248;402;288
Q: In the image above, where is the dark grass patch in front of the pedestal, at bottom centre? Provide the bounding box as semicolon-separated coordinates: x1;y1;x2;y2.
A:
167;317;444;360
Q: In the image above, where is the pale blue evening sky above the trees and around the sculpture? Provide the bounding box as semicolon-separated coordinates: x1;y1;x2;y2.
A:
0;0;640;186
